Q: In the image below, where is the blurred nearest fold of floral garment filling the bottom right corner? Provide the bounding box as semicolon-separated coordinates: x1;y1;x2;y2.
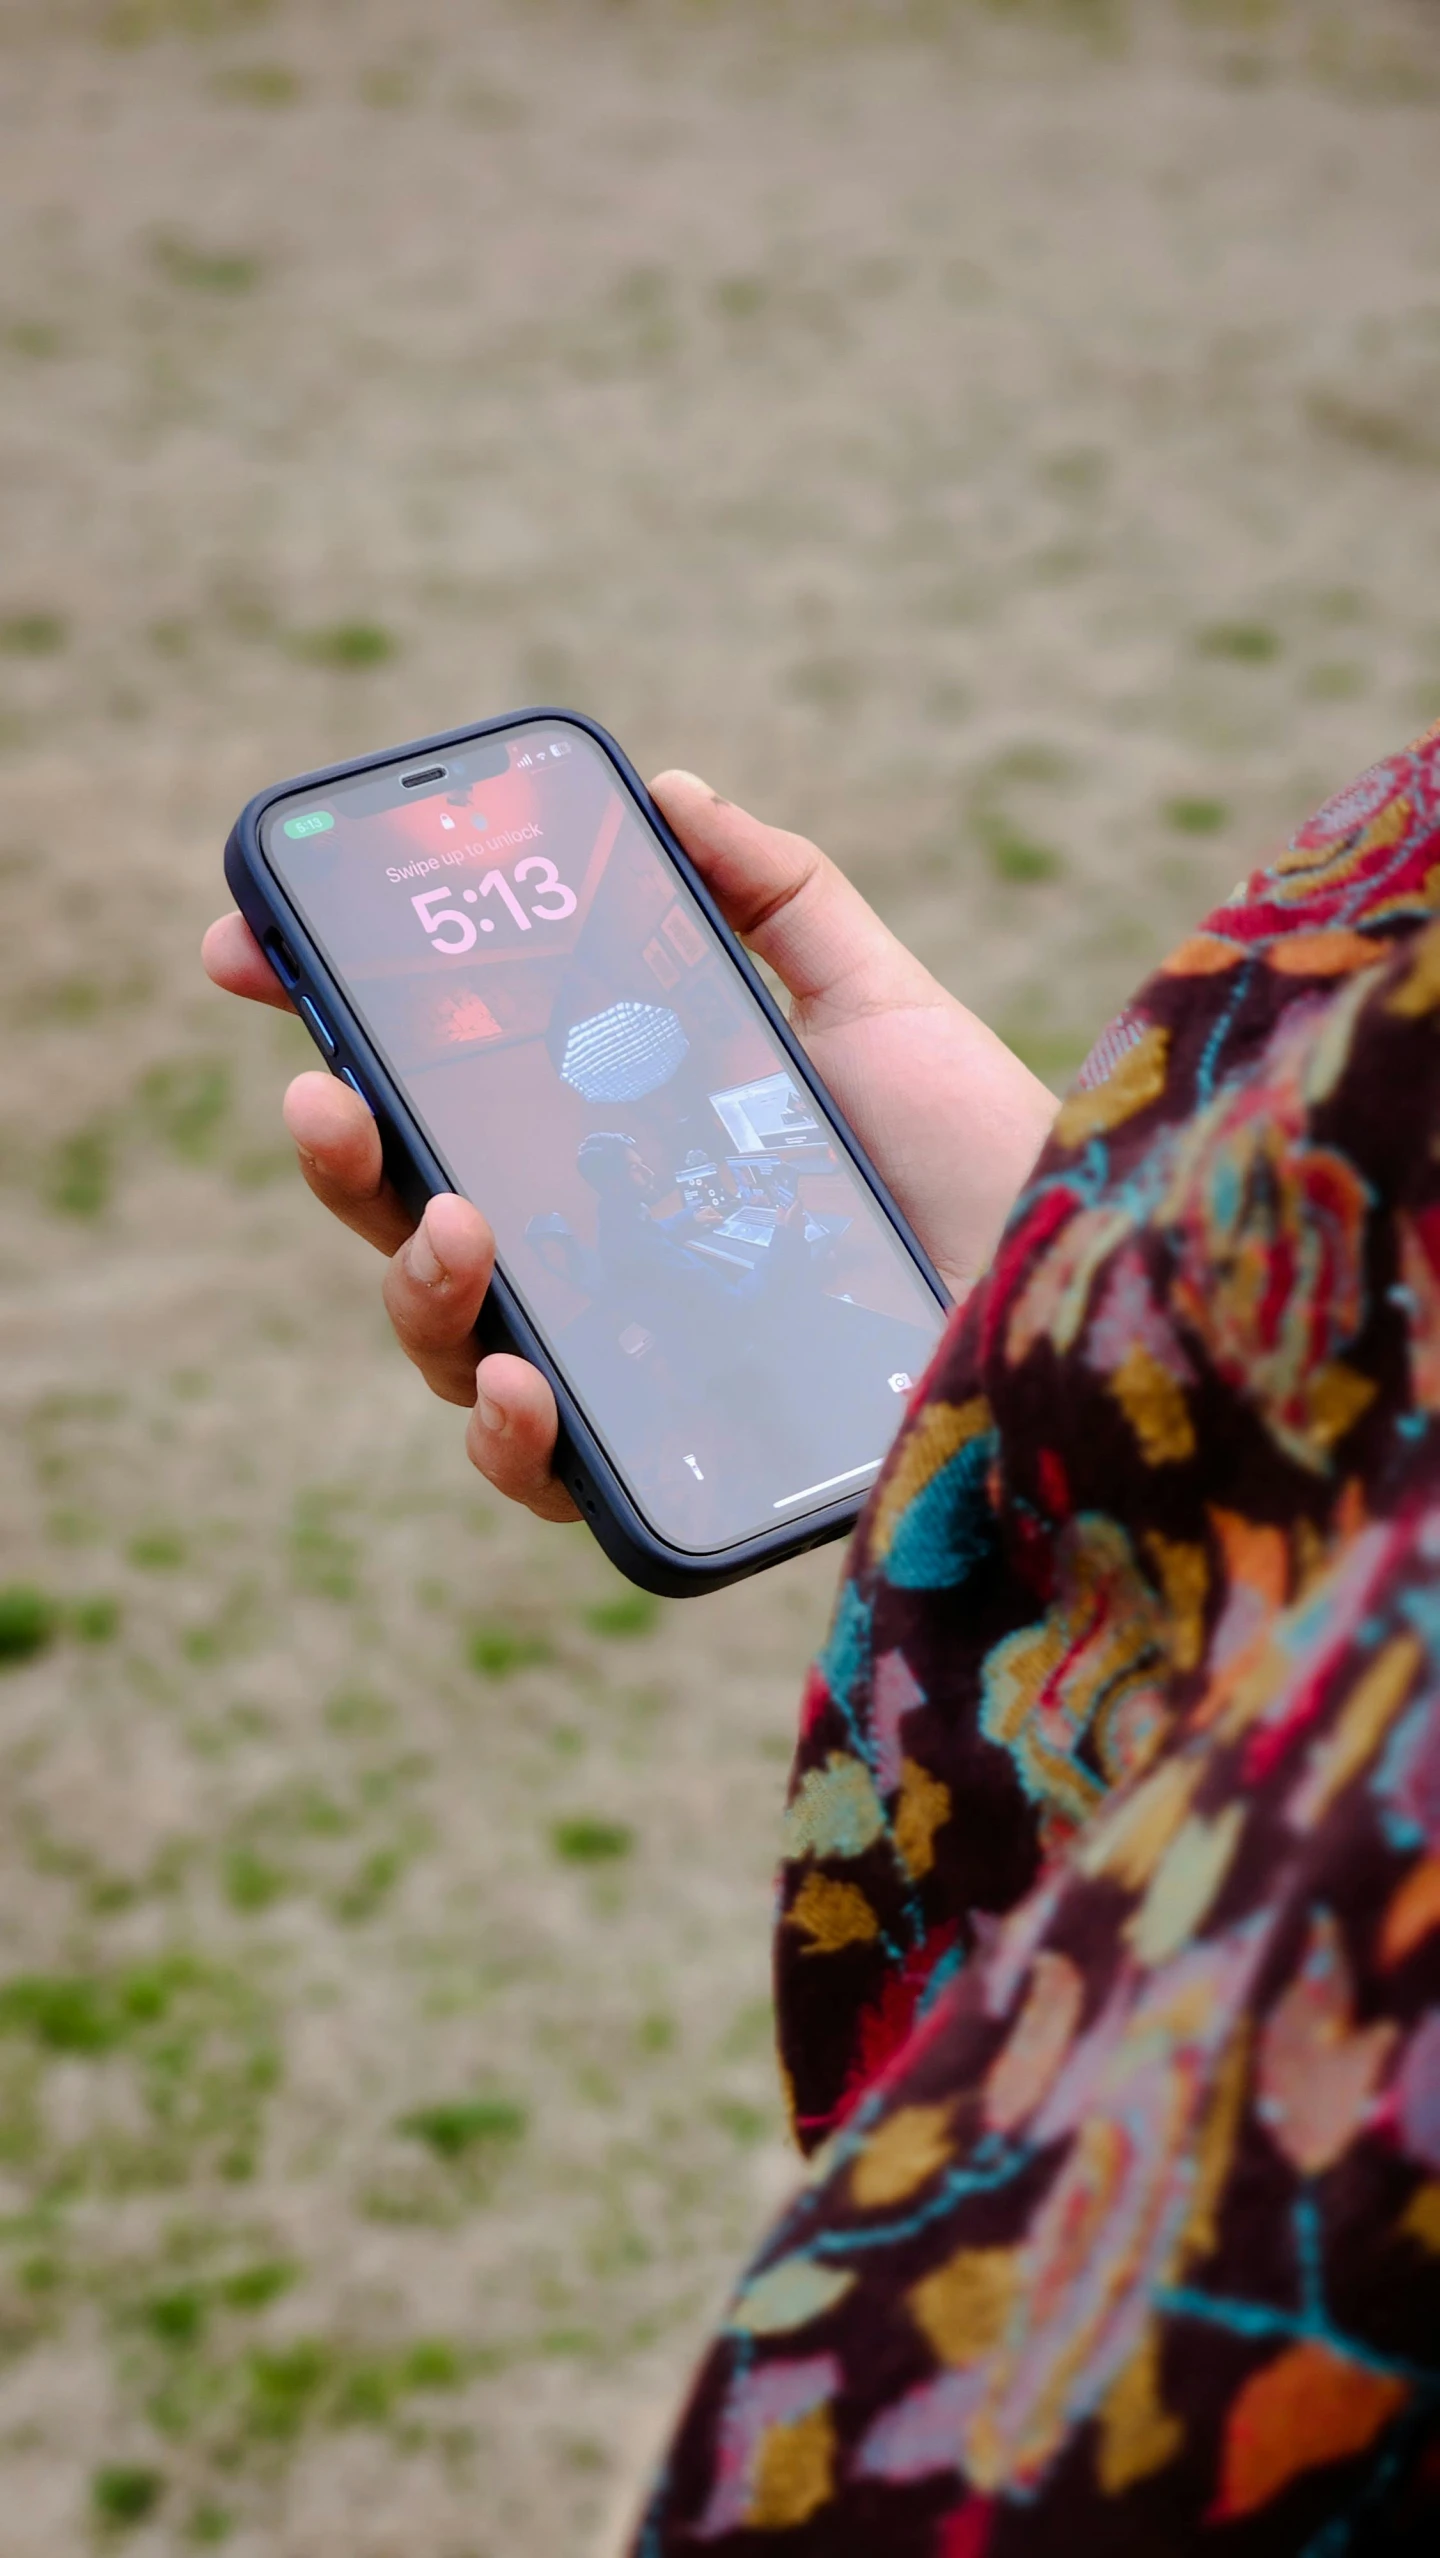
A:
639;1502;1440;2558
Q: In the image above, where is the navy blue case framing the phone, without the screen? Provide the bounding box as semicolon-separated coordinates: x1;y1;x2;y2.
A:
225;709;949;1599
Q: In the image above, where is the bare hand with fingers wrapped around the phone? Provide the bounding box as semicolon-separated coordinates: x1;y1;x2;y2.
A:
202;773;1056;1519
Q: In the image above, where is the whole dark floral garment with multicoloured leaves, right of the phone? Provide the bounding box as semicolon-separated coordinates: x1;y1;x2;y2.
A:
637;732;1440;2558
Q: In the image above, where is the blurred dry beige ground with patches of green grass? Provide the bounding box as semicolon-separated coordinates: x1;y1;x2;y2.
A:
0;0;1440;2558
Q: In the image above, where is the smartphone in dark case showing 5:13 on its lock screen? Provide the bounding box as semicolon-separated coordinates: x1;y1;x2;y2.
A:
225;711;946;1596
